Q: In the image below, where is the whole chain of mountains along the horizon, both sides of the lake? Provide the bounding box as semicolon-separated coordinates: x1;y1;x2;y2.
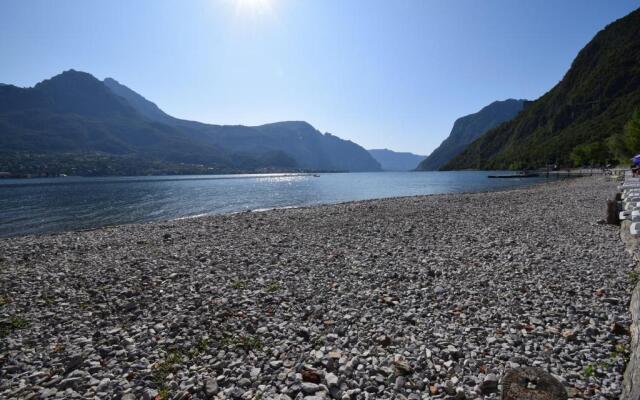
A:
0;5;640;175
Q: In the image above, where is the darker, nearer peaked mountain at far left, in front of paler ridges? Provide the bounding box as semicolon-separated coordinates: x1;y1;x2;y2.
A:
0;70;230;166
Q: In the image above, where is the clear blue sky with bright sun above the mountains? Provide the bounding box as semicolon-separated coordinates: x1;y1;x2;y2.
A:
0;0;640;154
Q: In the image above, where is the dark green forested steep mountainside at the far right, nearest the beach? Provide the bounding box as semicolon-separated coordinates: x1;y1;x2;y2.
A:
445;9;640;169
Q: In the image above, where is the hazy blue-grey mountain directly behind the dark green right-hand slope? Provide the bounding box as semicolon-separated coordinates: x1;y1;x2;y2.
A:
416;99;525;171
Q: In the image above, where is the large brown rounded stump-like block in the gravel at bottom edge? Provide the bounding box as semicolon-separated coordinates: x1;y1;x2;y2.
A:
502;367;568;400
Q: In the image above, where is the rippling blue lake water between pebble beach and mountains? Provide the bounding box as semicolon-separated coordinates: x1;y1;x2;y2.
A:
0;171;544;236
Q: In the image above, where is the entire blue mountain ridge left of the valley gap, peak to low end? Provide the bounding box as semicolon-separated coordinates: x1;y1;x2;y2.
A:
0;70;380;174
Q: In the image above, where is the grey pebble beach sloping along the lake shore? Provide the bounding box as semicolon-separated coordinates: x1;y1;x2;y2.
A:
0;178;635;400
